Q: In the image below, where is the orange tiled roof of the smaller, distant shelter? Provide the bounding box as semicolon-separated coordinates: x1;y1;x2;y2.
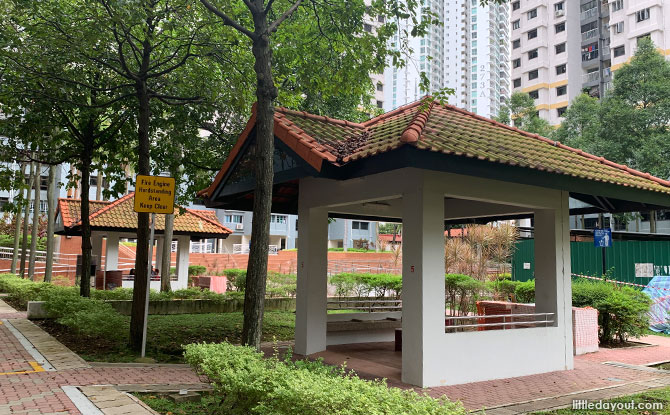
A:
59;192;232;236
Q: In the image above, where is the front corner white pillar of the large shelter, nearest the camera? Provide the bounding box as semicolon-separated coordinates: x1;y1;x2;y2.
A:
402;179;453;386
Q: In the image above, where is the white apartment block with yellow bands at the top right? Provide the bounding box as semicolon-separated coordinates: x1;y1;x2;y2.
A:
511;0;670;125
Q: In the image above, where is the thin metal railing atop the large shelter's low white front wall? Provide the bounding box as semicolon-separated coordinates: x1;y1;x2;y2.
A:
445;313;555;332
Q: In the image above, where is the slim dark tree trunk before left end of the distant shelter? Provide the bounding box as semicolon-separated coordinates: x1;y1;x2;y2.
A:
79;158;93;297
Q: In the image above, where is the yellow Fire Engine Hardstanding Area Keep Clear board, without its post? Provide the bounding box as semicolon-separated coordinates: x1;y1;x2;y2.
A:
135;174;175;214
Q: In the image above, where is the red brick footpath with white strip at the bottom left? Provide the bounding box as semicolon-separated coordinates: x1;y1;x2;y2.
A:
0;300;205;415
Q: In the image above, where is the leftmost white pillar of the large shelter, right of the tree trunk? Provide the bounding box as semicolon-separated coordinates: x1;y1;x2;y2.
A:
295;201;328;355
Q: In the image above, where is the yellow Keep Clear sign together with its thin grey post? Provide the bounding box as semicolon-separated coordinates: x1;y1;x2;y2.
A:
134;174;175;357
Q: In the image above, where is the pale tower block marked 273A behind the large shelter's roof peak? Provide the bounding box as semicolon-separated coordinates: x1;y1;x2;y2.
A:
384;0;510;117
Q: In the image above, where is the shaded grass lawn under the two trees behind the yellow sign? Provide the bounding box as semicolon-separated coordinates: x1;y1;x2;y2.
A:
37;311;295;363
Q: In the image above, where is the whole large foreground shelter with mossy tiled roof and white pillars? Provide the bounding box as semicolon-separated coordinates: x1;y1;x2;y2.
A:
200;97;670;386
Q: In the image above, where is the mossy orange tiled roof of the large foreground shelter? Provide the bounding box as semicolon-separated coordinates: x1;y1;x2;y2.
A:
199;98;670;197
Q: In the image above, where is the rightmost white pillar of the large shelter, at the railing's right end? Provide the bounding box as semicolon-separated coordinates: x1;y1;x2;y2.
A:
535;192;574;369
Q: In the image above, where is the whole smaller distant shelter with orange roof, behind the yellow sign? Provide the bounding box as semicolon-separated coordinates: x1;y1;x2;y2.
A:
56;192;232;289
